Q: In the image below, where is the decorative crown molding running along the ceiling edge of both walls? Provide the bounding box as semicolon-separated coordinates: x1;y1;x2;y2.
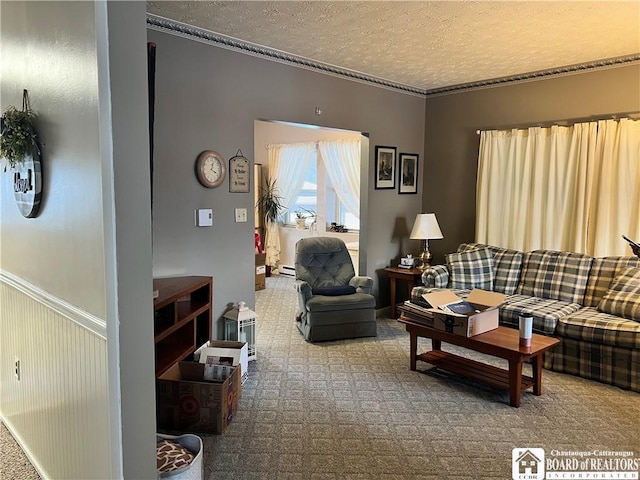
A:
147;13;640;97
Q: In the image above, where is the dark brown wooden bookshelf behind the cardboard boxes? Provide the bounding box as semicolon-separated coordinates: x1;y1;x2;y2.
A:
153;276;213;377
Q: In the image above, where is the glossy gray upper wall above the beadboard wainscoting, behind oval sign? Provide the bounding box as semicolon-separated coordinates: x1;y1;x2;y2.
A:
0;2;106;318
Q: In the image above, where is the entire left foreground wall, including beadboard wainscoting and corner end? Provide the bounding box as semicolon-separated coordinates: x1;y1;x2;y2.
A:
0;1;156;478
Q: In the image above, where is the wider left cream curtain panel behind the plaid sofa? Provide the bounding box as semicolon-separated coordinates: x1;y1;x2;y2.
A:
476;122;597;252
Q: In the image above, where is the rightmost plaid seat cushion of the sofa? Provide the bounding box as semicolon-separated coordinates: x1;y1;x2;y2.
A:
556;307;640;349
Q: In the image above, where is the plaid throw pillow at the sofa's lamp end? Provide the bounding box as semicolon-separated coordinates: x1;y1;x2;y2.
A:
446;247;493;291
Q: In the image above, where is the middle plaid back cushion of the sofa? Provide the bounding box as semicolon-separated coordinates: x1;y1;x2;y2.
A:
517;250;593;304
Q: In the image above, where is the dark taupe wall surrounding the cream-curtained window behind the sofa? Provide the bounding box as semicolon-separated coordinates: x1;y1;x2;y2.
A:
423;65;640;263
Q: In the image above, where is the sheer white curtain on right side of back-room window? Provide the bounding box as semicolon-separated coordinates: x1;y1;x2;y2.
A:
318;138;360;218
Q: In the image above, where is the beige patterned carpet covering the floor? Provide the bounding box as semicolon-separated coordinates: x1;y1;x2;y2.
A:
0;275;640;480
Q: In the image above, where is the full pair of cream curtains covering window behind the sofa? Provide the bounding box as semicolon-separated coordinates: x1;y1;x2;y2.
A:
476;120;640;256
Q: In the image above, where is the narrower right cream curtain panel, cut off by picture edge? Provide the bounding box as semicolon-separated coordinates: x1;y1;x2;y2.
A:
588;119;640;256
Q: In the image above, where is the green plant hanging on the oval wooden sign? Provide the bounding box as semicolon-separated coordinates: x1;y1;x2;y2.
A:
0;90;40;171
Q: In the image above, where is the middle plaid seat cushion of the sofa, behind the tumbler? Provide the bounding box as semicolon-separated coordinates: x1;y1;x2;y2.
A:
500;295;582;335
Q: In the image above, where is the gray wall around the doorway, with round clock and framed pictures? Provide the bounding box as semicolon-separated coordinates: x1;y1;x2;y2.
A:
148;30;425;319
